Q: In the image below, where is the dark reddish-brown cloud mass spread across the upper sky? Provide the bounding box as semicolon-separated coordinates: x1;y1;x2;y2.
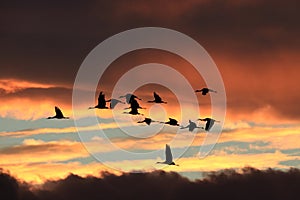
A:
0;0;300;118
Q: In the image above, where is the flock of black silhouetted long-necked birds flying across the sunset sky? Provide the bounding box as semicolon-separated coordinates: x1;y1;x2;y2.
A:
47;88;220;166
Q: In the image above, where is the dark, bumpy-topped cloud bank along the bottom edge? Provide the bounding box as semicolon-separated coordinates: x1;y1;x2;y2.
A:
0;168;300;200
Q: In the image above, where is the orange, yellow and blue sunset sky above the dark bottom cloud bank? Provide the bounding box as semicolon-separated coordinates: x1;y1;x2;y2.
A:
0;0;300;183
